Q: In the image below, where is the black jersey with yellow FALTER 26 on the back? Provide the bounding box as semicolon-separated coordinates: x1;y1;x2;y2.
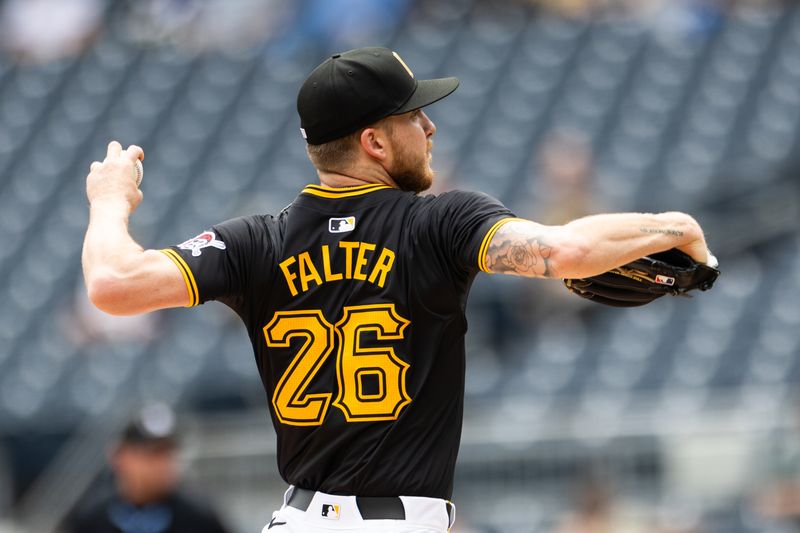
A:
163;185;512;498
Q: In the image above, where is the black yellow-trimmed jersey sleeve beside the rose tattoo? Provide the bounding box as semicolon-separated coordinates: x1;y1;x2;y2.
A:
416;191;515;272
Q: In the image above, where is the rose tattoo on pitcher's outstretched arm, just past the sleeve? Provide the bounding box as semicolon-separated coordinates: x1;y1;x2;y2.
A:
486;224;558;278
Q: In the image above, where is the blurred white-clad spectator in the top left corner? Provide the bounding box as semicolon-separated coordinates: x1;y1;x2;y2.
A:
0;0;105;63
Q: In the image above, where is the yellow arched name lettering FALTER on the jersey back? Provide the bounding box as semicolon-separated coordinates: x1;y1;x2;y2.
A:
279;241;395;296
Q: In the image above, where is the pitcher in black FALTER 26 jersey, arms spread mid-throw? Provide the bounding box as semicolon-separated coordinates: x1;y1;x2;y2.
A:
83;48;710;533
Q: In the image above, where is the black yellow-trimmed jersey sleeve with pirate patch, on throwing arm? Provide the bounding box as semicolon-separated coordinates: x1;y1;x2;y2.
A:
161;216;274;311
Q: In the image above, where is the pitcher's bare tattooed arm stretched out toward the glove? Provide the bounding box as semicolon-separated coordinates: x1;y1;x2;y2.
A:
486;213;707;278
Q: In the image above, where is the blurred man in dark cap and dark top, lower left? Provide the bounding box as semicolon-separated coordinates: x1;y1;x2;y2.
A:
66;404;228;533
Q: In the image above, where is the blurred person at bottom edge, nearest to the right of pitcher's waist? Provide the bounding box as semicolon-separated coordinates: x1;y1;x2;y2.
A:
554;477;652;533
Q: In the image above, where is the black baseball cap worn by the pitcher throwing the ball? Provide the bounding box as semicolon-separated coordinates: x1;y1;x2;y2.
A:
297;47;459;144
